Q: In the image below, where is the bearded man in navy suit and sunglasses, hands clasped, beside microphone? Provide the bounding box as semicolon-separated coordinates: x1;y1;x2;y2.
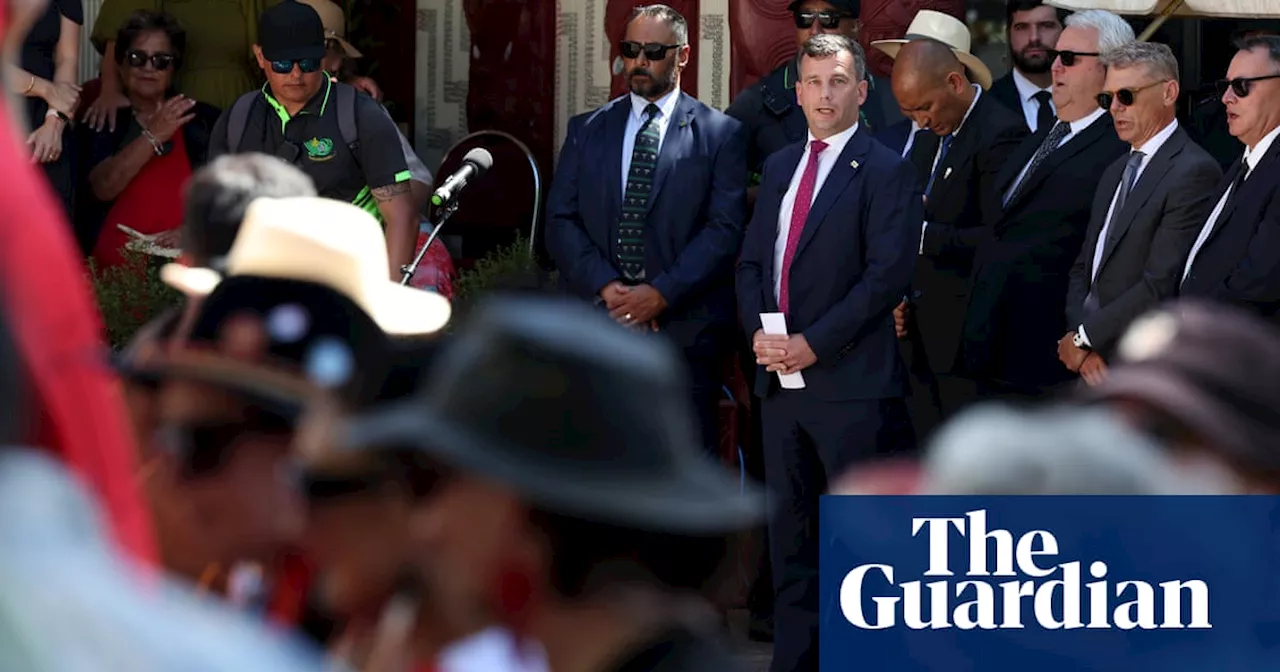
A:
547;5;746;451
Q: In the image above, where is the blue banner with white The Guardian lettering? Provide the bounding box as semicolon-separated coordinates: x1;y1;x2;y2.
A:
819;497;1280;672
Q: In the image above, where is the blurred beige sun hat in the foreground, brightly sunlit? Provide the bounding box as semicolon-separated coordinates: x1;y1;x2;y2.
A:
160;197;452;335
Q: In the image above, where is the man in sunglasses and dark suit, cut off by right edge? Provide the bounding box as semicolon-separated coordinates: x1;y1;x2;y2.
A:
1181;36;1280;319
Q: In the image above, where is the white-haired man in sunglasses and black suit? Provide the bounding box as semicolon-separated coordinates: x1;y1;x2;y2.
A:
960;10;1134;398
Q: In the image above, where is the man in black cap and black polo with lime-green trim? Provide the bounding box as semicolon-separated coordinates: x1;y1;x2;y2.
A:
209;0;419;280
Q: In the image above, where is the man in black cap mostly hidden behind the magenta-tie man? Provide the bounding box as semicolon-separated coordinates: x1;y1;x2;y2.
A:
724;0;902;204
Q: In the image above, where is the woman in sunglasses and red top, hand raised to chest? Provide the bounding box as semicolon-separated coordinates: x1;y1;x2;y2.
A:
78;10;218;268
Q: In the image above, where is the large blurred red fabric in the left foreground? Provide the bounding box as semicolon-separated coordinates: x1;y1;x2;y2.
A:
0;106;156;564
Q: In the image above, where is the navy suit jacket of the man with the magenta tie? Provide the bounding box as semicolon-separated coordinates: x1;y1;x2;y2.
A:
737;127;923;401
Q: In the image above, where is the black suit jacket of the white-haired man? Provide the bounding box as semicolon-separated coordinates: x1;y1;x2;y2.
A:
961;114;1129;390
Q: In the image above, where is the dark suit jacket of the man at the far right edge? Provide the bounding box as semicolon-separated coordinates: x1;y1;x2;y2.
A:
1181;135;1280;319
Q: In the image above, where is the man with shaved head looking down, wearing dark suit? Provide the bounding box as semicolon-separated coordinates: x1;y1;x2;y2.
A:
892;38;1027;434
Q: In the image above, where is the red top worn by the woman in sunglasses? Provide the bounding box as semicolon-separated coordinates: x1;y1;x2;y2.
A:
93;133;191;269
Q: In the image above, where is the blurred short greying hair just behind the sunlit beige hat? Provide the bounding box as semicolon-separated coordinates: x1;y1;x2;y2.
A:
182;154;316;266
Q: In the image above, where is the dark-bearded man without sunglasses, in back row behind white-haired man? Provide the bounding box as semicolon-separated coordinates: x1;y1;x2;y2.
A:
991;0;1068;133
